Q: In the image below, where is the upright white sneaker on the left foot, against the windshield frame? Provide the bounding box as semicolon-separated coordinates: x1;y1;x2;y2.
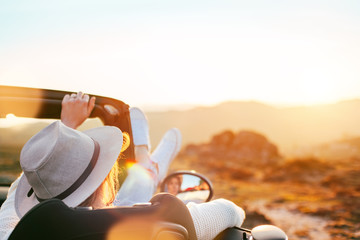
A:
130;107;151;152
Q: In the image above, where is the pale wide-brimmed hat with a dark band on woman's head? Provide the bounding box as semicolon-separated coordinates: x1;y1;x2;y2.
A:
15;121;123;218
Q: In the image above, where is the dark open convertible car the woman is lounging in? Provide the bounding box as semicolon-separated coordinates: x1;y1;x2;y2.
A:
0;86;287;240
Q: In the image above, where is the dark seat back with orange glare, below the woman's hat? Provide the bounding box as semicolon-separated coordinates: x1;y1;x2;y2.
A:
9;194;196;240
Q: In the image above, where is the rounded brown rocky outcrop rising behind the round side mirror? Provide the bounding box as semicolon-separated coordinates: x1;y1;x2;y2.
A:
175;130;283;180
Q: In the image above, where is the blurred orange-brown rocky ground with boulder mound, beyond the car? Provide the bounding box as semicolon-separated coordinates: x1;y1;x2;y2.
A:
171;131;360;240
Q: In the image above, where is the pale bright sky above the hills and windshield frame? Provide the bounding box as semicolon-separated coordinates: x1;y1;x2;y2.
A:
0;0;360;109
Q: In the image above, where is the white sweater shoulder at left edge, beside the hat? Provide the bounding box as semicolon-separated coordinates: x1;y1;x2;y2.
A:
0;177;20;240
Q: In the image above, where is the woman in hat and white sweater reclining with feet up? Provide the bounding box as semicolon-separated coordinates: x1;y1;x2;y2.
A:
0;93;245;239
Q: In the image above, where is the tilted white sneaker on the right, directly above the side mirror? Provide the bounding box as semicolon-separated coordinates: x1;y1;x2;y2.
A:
151;128;181;183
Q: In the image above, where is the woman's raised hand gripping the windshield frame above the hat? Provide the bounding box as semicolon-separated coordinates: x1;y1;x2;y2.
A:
61;92;95;129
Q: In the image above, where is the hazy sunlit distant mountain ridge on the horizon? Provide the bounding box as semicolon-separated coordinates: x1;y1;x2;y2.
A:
146;100;360;152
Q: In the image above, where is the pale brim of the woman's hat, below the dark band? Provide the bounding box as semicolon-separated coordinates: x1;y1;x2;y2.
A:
15;126;123;218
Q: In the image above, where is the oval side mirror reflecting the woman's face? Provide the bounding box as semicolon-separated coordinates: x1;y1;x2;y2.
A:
160;171;214;204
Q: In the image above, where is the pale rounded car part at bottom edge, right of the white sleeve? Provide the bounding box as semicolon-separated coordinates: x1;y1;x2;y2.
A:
251;225;288;240
